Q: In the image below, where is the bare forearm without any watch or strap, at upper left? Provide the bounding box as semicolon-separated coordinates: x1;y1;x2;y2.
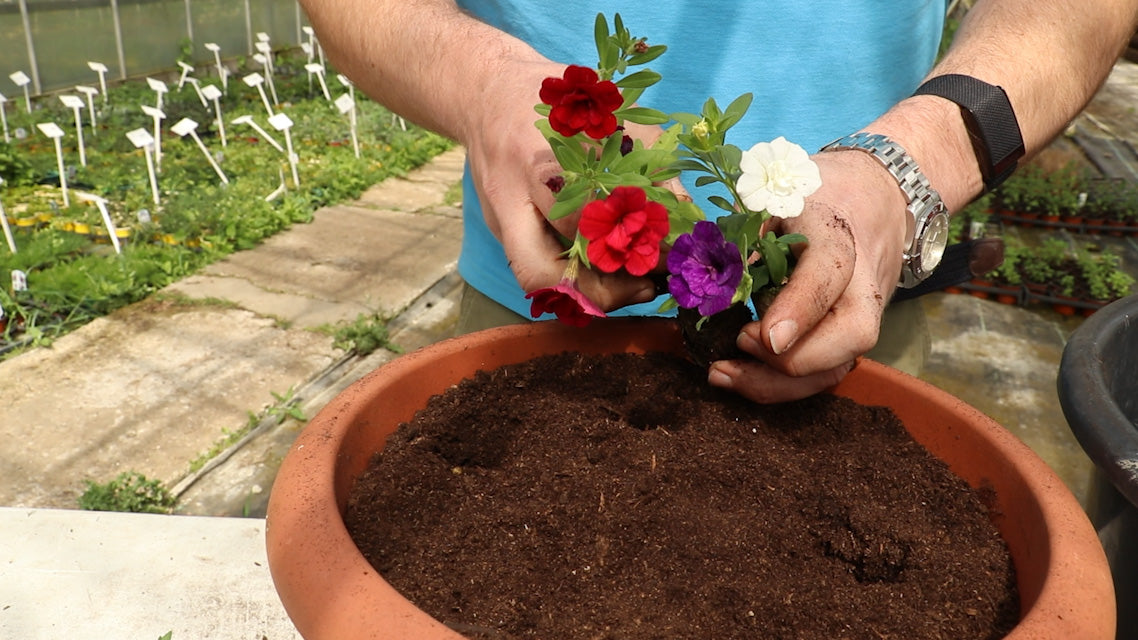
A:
300;0;544;142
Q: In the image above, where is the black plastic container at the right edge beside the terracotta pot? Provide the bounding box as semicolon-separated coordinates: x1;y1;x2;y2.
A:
1058;295;1138;640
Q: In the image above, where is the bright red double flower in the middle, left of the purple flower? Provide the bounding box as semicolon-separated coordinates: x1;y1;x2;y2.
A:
577;187;668;276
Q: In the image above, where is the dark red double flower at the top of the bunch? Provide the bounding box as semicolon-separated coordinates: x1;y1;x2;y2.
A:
538;65;625;140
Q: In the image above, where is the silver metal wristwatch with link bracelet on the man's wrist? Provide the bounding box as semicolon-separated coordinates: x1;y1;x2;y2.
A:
822;133;948;288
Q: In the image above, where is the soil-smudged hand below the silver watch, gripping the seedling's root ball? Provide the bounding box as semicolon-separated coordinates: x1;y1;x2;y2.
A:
708;150;908;402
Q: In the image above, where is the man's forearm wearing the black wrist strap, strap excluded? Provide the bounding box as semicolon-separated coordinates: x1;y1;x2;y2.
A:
866;0;1138;211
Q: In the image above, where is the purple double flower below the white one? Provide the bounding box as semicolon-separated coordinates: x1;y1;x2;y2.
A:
668;221;743;315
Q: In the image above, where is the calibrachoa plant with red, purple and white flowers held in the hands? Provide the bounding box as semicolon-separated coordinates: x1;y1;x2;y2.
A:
526;14;822;326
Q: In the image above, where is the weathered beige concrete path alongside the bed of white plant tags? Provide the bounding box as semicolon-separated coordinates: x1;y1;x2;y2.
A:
0;145;463;508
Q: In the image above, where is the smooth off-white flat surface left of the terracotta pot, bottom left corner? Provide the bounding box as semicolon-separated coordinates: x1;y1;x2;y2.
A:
0;508;300;640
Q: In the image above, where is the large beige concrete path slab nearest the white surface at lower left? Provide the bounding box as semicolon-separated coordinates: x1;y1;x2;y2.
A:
0;301;337;508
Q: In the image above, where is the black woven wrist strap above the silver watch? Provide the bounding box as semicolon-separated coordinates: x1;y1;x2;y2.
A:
913;74;1024;191
